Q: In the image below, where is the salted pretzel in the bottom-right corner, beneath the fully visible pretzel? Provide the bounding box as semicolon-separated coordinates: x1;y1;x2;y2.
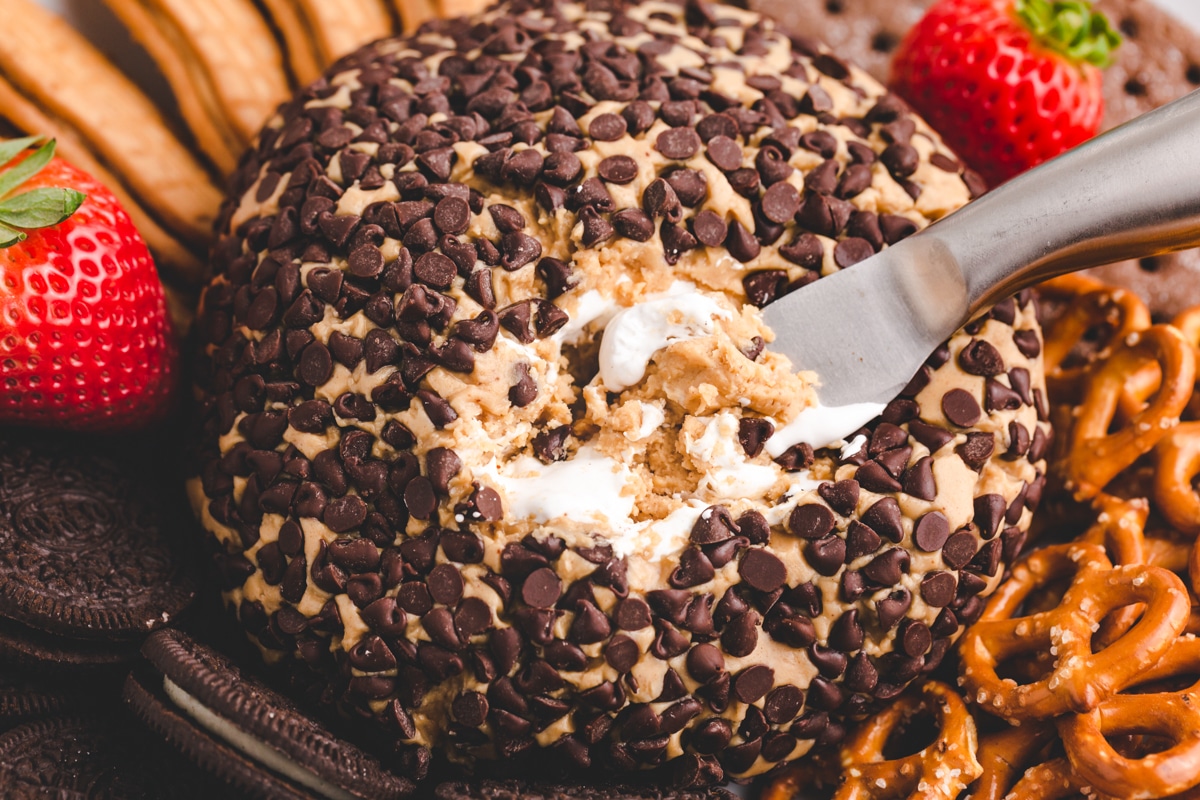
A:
1058;638;1200;800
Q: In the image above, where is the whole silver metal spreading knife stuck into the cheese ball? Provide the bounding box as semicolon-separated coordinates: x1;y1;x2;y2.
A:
763;90;1200;416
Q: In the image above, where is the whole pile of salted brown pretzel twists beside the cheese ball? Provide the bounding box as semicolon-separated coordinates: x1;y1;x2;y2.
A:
762;276;1200;800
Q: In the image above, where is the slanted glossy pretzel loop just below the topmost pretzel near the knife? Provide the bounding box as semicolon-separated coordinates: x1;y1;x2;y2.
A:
1066;325;1195;500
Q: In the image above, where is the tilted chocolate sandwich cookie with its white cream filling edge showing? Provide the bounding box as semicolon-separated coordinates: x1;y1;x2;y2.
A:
125;628;415;800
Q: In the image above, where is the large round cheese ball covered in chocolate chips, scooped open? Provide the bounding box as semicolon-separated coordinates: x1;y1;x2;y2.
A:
182;0;1049;782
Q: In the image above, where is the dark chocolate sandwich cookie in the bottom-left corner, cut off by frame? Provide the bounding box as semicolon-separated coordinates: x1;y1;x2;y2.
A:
0;709;219;800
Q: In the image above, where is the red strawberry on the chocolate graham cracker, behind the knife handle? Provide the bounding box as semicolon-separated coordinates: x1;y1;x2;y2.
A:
890;0;1121;186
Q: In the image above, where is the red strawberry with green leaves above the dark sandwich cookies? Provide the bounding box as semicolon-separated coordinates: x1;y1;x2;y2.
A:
0;138;178;431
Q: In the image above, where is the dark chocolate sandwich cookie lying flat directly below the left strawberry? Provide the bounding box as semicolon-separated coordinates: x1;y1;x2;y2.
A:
0;437;196;668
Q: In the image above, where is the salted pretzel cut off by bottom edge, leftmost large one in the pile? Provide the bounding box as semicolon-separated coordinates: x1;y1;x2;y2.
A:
834;681;983;800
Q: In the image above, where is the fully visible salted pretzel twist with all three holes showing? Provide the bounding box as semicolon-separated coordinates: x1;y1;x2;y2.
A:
960;543;1190;720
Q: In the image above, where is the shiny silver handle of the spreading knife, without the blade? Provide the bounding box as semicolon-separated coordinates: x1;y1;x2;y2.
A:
922;90;1200;319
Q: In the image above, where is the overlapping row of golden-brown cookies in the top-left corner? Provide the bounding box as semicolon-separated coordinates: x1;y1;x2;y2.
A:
0;0;485;326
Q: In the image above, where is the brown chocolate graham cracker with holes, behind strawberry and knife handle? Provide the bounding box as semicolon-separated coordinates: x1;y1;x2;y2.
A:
750;0;1200;319
